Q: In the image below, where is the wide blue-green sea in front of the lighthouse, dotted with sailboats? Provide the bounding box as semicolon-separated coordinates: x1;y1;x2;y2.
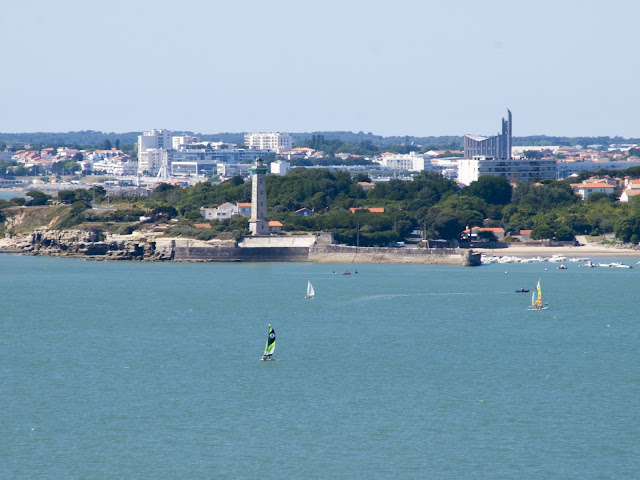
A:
0;255;640;479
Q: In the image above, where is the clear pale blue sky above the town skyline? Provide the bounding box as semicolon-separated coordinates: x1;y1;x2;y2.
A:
0;0;640;138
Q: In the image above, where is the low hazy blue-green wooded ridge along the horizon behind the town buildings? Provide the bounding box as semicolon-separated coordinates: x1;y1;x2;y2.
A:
0;130;640;150
